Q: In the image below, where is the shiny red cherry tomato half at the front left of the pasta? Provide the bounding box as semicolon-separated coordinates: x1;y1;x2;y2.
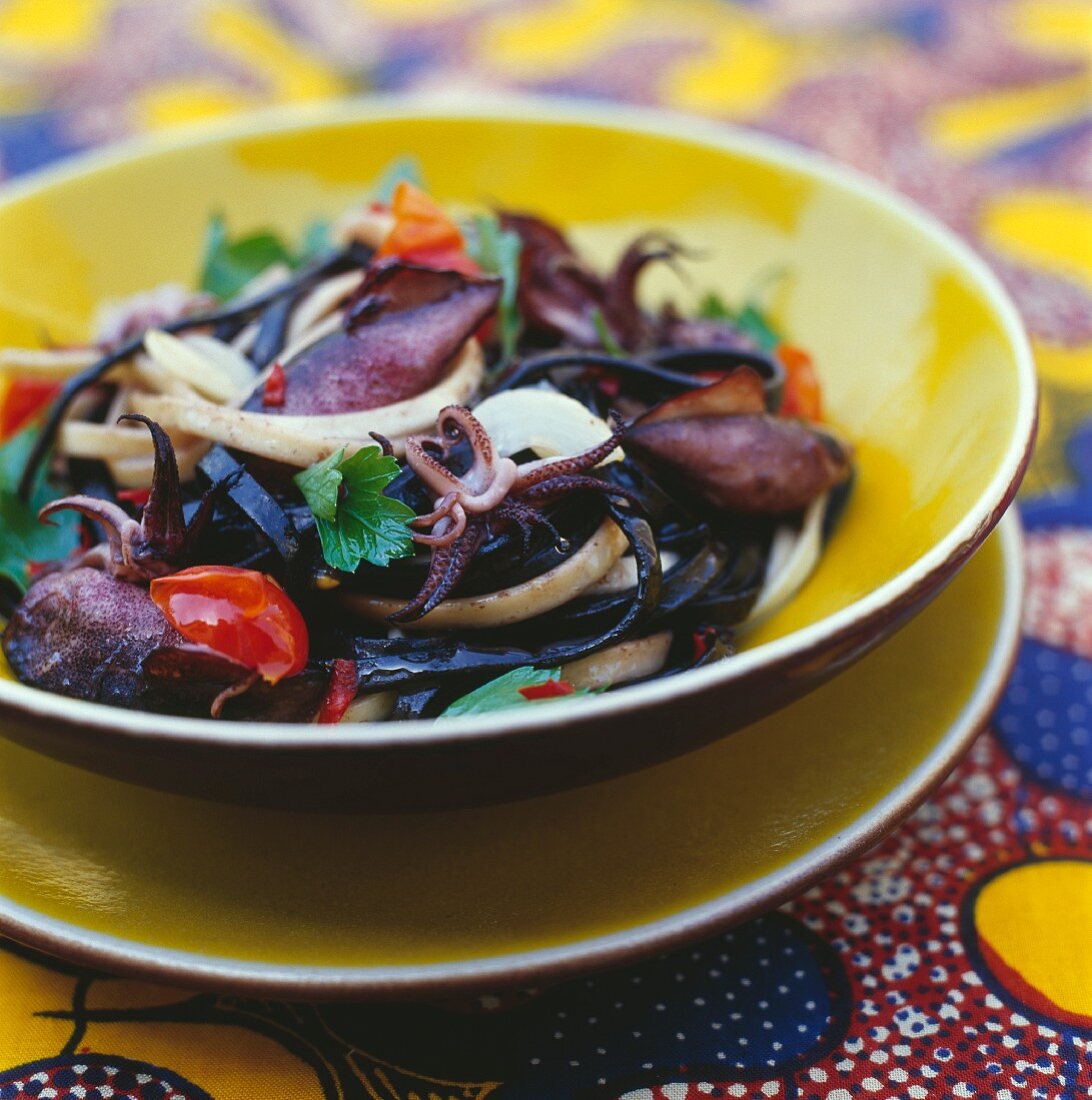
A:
151;565;308;684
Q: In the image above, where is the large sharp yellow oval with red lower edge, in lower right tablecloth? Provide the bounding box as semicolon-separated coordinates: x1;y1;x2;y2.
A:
974;859;1092;1023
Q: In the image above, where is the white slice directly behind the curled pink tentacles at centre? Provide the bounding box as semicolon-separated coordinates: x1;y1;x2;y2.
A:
474;388;625;465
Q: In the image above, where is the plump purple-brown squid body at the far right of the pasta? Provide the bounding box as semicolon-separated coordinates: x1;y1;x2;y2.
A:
626;416;852;515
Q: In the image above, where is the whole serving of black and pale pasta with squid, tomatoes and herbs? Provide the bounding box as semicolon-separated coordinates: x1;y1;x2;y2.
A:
0;171;852;722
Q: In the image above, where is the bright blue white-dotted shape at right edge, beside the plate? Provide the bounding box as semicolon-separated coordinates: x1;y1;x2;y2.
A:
994;639;1092;801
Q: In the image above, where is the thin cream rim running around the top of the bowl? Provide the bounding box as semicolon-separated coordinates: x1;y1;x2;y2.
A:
0;96;1037;754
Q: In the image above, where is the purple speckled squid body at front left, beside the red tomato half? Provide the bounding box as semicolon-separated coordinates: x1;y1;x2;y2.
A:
3;567;329;722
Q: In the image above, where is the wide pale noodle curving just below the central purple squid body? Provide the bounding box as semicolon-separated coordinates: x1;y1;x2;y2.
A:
134;340;484;466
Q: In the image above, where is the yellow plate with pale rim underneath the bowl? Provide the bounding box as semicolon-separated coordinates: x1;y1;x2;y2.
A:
0;518;1021;998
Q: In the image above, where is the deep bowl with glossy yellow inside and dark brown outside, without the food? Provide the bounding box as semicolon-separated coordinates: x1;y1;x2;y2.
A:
0;99;1036;809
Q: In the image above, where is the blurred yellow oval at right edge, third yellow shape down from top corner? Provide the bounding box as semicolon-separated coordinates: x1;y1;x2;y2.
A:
981;188;1092;288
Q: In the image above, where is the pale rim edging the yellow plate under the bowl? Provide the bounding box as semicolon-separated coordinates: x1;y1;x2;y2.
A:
0;516;1024;1001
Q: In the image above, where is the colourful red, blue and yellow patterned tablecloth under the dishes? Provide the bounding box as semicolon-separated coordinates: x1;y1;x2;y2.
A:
0;0;1092;1100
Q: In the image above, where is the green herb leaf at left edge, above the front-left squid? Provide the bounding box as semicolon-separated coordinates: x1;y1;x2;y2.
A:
0;428;79;592
